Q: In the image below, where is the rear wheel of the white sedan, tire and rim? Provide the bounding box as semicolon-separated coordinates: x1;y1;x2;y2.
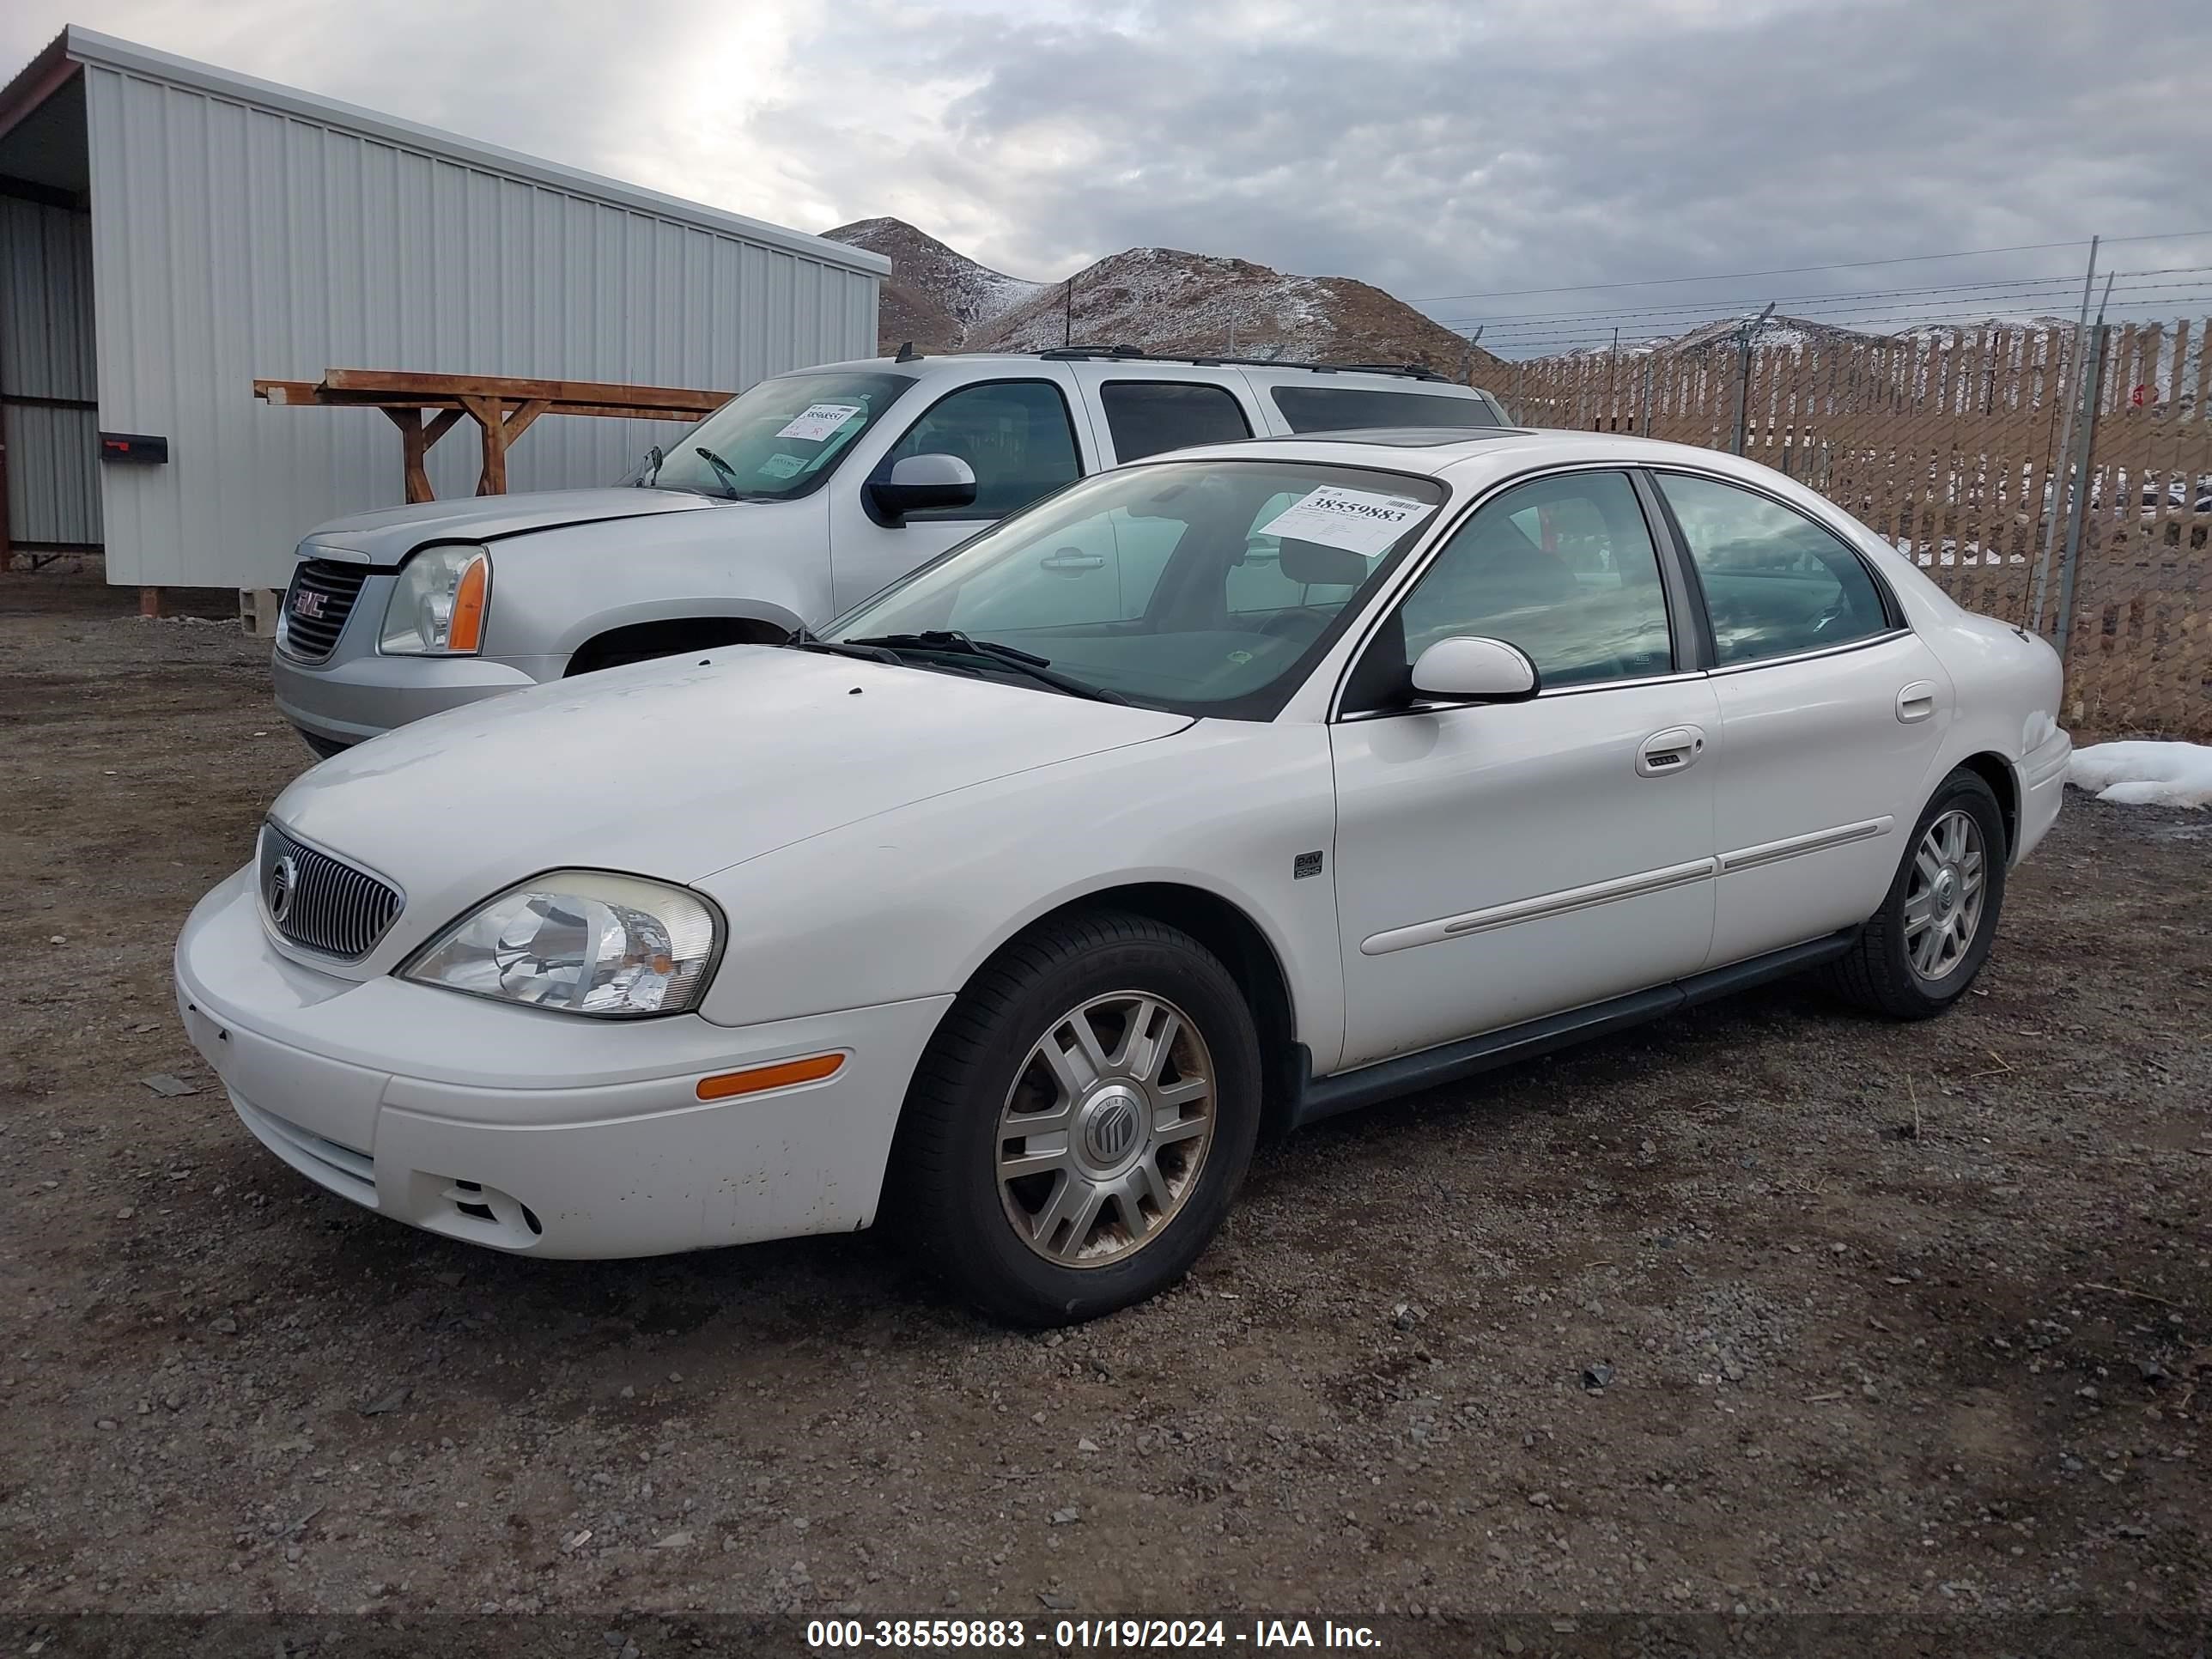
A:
1834;768;2006;1020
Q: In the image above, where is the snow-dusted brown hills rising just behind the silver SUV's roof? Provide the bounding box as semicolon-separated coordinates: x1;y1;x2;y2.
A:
823;219;1498;378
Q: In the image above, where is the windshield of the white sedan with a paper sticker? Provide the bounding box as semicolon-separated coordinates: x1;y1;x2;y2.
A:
823;460;1444;719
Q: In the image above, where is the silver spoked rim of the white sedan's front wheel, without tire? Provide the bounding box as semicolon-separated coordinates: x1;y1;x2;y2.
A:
998;991;1214;1267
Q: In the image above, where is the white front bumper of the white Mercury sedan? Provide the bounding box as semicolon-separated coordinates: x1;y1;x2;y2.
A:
175;869;951;1256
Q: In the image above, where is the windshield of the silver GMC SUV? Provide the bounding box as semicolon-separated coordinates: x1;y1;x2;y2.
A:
635;374;914;502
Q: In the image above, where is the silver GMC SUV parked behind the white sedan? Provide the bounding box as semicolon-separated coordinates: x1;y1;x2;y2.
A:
272;347;1509;754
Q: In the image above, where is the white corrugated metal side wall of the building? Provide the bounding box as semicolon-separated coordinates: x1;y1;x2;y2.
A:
83;64;876;586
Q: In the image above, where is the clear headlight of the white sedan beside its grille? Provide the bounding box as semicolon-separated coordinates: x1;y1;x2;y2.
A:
400;869;721;1020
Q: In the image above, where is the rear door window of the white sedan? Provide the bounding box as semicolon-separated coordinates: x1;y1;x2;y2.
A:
1656;473;1889;668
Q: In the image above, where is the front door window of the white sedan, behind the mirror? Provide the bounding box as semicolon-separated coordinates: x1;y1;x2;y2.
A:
1360;473;1674;686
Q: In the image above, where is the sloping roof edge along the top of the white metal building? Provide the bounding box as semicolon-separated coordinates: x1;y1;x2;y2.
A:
0;24;891;276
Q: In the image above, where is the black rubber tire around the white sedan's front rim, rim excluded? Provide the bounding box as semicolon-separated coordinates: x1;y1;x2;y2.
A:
883;911;1261;1328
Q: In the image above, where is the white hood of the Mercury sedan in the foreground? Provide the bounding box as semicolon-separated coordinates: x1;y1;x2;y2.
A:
270;646;1192;975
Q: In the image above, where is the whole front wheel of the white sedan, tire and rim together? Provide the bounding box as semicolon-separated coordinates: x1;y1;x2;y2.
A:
884;914;1261;1325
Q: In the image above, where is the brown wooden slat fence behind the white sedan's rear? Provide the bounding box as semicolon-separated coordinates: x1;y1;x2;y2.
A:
1491;321;2212;741
